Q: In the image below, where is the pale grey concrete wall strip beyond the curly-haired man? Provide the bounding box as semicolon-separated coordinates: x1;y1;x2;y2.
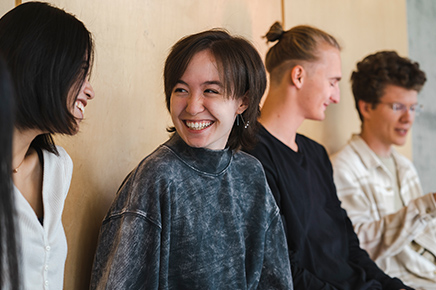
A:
407;0;436;193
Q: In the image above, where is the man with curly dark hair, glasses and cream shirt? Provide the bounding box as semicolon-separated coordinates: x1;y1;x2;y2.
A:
332;51;436;290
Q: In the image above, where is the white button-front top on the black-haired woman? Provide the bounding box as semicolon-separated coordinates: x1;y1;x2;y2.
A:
14;146;73;290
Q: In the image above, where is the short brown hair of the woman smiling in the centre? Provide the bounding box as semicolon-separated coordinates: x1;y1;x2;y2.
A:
164;29;266;150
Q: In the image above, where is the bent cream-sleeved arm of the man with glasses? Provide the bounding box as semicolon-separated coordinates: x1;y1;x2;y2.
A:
334;158;436;260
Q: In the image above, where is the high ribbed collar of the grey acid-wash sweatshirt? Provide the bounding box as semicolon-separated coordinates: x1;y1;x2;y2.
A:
164;132;233;175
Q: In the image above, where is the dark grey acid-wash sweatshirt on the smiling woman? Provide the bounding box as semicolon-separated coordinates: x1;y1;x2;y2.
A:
91;134;293;290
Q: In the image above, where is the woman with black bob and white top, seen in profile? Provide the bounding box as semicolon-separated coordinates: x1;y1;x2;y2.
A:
0;2;94;289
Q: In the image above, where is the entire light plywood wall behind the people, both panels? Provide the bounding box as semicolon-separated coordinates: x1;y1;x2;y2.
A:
0;0;410;290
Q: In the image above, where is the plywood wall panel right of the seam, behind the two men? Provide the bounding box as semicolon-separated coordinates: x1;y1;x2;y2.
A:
285;0;411;157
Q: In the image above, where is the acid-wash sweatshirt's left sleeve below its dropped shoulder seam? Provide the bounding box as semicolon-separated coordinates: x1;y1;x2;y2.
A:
90;212;160;289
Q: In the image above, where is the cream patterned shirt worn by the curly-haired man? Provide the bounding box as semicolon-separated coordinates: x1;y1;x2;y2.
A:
332;135;436;290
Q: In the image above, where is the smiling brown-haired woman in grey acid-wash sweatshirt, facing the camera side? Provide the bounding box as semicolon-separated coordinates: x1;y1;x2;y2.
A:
91;30;292;289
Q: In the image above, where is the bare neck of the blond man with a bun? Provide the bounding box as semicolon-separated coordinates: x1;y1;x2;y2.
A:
259;86;304;151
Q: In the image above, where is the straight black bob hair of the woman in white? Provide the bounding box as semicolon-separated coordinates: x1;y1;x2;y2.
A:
0;2;94;154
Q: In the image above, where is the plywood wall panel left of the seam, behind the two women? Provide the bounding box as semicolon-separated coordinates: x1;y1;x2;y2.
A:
24;0;281;290
